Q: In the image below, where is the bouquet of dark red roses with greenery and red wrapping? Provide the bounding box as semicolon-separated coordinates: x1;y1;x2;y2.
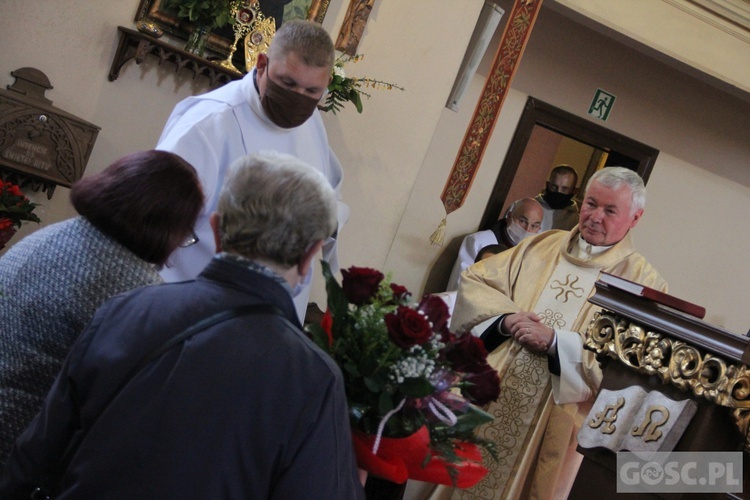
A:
308;262;500;487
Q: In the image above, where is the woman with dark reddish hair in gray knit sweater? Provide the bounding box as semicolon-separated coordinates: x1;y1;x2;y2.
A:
0;150;203;469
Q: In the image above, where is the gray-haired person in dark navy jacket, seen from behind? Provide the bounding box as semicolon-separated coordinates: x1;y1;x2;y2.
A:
0;153;364;500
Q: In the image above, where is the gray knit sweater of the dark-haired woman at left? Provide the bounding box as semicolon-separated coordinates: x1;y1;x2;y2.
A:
0;217;162;469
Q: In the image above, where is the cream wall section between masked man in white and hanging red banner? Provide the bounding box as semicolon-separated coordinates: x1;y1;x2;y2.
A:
320;0;483;278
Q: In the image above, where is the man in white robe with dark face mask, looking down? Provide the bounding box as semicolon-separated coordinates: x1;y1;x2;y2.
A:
156;21;349;321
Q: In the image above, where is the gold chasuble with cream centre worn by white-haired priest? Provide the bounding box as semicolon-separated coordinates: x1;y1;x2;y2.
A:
433;227;666;499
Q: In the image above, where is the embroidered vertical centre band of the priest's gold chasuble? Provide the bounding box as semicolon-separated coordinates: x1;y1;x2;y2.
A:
453;259;599;499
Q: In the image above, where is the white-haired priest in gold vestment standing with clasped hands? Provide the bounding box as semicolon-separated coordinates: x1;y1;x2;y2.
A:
424;167;667;499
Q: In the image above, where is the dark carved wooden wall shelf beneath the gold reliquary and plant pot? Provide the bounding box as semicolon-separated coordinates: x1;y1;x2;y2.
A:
109;26;245;85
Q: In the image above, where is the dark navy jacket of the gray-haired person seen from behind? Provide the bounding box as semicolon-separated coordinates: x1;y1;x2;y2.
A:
0;258;363;500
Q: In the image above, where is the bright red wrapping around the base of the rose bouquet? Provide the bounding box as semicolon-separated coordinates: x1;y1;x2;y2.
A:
352;427;487;488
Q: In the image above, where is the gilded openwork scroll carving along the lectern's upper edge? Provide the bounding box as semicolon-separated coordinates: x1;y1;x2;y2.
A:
584;312;750;451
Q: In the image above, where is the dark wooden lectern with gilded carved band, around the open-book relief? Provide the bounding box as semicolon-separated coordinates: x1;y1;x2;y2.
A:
569;280;750;500
